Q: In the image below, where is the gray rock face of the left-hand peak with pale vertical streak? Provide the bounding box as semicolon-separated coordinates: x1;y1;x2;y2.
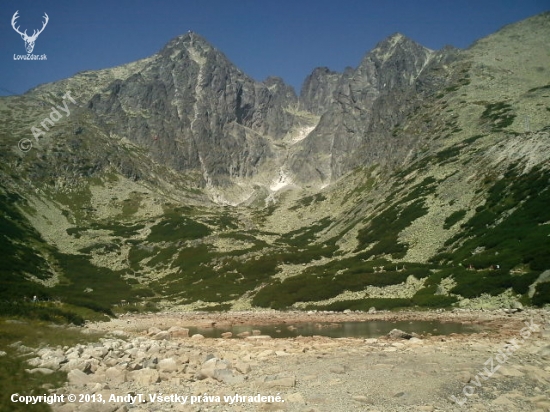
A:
88;33;297;186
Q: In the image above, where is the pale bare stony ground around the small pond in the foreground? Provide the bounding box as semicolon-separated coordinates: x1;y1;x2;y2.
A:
24;309;550;412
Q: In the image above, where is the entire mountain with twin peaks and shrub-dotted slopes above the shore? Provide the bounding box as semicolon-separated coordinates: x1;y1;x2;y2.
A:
0;14;550;316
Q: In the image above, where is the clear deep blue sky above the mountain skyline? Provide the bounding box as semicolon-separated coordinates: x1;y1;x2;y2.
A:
0;0;550;95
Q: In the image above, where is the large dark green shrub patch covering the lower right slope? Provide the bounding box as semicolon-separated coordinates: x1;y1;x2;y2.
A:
431;165;550;305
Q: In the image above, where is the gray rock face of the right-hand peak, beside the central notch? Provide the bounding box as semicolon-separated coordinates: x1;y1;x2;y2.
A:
290;34;458;182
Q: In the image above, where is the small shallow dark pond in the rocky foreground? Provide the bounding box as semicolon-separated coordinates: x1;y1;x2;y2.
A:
189;321;480;338
